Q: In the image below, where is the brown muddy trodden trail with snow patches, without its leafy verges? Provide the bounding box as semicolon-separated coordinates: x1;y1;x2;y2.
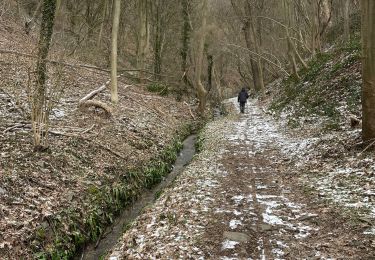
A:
205;109;374;259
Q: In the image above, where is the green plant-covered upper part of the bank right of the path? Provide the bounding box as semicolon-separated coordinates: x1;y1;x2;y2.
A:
270;37;361;130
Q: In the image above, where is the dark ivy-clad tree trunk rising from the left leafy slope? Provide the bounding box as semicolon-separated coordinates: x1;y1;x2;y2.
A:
31;0;56;150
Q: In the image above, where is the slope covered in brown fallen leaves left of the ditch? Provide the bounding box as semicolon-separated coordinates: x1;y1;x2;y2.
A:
0;18;198;259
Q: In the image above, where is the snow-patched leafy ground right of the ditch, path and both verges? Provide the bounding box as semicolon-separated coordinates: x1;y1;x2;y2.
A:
109;100;375;260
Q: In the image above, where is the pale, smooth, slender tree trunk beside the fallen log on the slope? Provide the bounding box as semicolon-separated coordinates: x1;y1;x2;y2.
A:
111;0;121;104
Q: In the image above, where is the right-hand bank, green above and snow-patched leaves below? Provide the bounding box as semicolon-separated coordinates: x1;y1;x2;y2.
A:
263;37;375;241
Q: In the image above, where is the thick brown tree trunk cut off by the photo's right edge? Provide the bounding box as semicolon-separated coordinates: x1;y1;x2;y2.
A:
361;0;375;141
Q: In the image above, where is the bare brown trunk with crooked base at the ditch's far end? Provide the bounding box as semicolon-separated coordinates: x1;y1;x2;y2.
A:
194;0;207;115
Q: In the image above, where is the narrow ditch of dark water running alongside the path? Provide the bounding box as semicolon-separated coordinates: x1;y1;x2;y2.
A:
75;135;197;260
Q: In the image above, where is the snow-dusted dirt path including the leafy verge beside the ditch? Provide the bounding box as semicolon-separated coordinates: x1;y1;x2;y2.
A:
107;99;375;259
